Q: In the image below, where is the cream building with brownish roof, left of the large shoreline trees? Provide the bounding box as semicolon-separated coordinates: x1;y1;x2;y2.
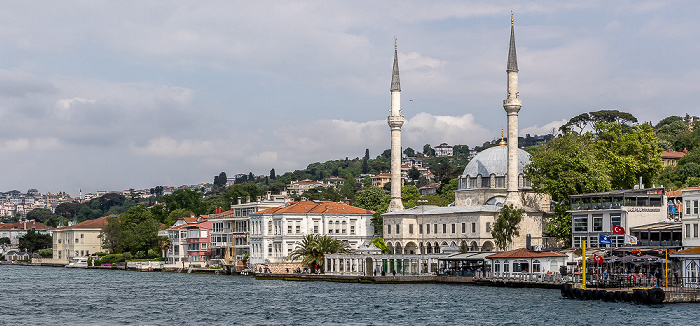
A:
53;216;109;264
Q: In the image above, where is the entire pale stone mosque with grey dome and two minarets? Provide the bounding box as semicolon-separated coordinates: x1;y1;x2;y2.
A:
383;16;549;255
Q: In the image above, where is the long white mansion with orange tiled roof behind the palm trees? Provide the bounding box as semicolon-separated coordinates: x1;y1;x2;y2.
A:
249;201;374;266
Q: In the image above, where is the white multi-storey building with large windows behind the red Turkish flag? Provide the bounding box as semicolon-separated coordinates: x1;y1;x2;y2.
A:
568;188;668;248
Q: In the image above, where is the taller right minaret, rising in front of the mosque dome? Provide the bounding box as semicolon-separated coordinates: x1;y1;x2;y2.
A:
503;13;522;207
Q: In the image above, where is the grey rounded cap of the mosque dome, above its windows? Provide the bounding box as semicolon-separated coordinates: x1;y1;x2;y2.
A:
462;146;530;178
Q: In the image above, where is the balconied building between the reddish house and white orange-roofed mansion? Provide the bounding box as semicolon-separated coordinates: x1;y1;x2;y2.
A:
209;193;287;264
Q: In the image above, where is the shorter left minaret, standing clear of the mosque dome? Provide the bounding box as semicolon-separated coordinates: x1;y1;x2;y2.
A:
387;39;404;212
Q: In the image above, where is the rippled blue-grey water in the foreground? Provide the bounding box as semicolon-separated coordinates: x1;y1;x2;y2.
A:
0;265;700;325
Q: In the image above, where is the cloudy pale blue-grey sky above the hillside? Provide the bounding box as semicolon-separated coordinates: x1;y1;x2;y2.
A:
0;0;700;194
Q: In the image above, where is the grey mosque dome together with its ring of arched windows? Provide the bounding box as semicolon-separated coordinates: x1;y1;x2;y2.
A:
459;146;530;189
